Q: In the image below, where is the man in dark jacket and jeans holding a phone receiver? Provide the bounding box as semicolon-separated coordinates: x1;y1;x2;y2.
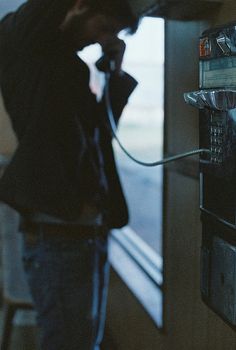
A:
0;0;140;350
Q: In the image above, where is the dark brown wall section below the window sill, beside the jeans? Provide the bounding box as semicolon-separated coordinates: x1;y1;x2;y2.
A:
102;270;168;350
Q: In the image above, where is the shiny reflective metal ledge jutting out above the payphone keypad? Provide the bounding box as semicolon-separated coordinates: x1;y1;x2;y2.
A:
184;89;236;111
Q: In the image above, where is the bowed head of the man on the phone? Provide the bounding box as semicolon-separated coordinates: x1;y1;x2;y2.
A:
61;0;139;50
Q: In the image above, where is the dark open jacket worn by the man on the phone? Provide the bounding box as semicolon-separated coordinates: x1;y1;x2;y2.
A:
0;0;136;227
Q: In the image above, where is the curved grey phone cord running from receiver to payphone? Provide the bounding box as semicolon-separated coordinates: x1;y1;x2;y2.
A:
105;73;211;167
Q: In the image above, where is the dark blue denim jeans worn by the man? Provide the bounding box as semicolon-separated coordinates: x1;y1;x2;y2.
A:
23;228;109;350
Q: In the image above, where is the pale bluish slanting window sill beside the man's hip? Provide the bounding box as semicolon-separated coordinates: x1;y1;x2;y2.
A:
109;227;163;329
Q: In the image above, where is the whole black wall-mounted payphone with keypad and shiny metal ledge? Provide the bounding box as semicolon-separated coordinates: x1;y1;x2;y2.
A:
184;23;236;329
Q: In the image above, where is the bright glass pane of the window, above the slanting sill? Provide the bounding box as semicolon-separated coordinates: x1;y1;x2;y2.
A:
114;18;164;254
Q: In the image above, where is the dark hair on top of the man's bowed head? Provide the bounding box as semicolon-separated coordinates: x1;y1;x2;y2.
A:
87;0;139;34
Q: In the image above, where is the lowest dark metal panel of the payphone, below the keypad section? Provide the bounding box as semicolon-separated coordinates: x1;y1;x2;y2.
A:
201;214;236;327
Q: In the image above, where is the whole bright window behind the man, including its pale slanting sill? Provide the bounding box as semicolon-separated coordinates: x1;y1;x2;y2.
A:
80;18;164;328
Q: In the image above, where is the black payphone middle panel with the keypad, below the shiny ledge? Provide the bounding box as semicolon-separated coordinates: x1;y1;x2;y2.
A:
199;109;236;229
